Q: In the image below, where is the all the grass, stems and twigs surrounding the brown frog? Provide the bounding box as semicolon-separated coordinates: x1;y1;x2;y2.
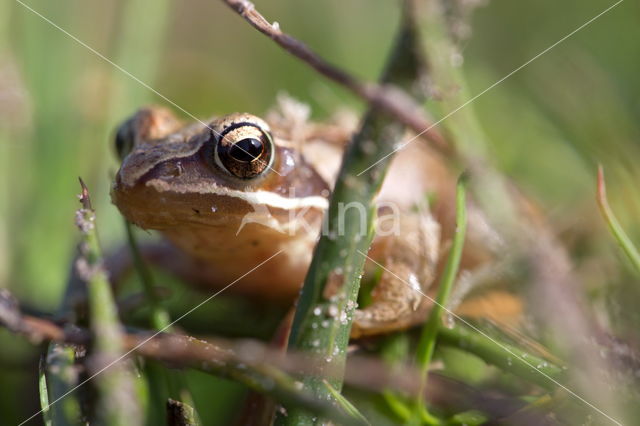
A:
0;0;640;426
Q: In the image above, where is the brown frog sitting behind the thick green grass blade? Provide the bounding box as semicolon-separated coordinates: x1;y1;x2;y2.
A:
111;100;460;336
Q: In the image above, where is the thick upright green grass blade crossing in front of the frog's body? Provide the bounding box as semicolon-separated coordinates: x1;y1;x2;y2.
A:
276;8;428;425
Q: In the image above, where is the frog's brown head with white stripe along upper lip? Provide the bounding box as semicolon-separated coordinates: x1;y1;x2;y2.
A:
111;107;328;235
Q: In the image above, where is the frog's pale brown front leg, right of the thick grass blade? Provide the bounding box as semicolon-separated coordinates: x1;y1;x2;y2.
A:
351;213;440;337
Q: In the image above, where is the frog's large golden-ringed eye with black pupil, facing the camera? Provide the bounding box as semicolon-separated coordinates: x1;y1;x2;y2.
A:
215;123;273;179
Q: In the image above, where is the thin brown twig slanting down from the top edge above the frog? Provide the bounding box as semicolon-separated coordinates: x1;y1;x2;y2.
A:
223;0;451;152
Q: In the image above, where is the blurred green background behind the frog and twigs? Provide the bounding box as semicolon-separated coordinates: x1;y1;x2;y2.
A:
0;0;640;424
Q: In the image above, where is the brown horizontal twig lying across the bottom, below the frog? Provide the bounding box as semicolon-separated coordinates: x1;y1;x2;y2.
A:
0;290;556;402
